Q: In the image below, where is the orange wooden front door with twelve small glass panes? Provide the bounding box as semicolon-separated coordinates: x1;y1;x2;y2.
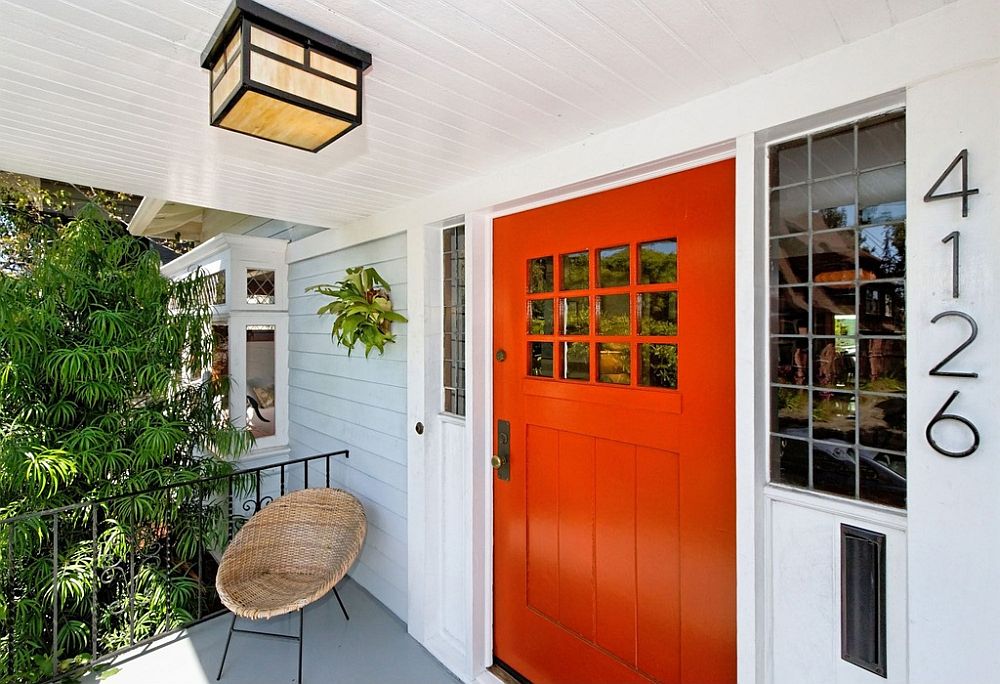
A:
493;161;736;684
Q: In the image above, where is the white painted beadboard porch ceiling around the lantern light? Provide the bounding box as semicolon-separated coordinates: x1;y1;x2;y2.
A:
0;0;946;226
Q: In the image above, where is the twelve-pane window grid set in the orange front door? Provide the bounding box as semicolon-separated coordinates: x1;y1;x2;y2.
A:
526;238;679;389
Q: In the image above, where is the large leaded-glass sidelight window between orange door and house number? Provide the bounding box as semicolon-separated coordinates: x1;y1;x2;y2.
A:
770;112;906;508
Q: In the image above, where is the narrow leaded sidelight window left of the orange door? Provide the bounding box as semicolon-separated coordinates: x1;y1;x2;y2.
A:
441;226;465;416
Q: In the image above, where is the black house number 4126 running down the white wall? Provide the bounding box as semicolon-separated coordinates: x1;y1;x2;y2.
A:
924;149;979;458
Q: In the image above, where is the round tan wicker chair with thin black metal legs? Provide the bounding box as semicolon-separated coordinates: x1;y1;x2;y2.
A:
215;489;368;684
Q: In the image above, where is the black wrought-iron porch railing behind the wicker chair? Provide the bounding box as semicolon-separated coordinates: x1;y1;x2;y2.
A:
0;450;349;684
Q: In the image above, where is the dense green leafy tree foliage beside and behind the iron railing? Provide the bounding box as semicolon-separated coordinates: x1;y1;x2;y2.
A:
0;195;252;683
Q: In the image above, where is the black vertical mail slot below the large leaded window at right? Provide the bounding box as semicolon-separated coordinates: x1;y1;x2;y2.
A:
840;524;887;677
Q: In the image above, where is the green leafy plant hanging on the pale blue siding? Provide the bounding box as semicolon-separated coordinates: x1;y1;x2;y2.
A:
306;266;406;358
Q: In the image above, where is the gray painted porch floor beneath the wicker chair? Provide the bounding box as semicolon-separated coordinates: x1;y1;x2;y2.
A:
84;578;459;684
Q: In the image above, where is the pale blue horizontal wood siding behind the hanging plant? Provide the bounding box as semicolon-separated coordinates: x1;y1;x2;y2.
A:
286;234;406;620
